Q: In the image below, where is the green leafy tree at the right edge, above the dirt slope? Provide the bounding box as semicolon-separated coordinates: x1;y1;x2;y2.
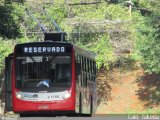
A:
134;1;160;73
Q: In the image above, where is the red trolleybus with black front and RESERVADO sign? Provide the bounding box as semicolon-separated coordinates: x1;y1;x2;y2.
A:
5;32;97;116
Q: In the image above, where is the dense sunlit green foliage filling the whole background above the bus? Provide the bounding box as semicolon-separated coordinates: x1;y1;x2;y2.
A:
0;0;160;73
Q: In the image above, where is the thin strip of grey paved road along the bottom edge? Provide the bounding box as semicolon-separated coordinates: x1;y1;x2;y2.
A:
0;114;160;120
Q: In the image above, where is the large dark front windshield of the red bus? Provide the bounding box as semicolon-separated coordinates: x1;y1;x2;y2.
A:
16;56;71;89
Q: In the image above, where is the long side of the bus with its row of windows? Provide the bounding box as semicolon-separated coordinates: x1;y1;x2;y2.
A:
75;50;97;114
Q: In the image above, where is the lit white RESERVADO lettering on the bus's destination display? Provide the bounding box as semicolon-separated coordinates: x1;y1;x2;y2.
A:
23;47;65;53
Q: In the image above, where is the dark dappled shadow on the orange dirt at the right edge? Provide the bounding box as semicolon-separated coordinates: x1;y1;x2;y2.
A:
137;73;160;108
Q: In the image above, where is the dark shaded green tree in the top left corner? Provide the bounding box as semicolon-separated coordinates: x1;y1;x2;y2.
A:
0;2;22;39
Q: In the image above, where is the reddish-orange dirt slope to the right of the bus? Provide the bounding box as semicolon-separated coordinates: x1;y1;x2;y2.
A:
96;69;160;114
